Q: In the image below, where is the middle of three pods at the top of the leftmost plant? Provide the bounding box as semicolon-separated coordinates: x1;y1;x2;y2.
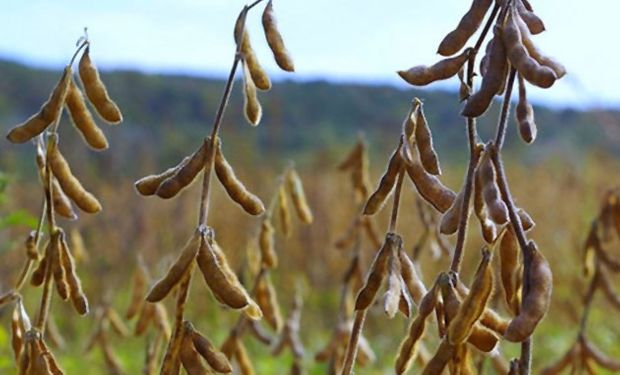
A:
65;78;108;150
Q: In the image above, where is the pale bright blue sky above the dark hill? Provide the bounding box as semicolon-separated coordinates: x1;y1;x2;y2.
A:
0;0;620;108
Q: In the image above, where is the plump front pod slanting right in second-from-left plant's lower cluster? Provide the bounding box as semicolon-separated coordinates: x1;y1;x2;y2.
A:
196;234;250;309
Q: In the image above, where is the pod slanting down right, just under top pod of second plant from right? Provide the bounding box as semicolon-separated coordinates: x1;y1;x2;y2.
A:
406;160;456;213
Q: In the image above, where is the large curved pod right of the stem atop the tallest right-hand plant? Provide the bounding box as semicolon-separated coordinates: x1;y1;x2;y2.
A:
501;9;557;88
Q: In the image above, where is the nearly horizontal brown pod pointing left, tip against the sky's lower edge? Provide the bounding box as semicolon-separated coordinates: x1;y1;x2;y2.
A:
398;48;471;86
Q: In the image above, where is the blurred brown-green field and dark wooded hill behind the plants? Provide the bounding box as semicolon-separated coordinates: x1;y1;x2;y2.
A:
0;61;620;374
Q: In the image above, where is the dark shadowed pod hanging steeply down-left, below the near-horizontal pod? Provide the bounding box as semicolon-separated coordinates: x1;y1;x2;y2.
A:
461;29;508;117
